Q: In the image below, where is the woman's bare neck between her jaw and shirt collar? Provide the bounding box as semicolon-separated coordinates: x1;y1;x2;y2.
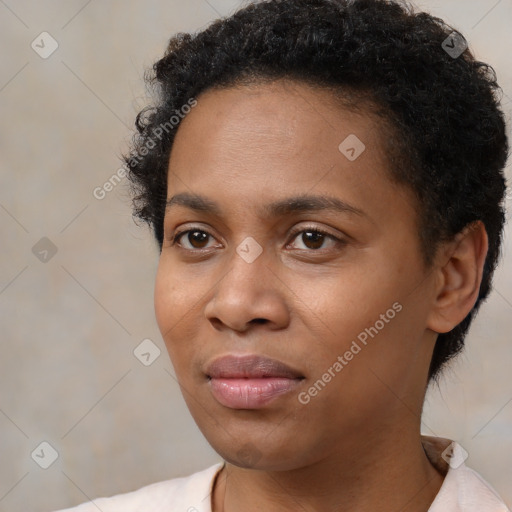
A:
213;431;444;512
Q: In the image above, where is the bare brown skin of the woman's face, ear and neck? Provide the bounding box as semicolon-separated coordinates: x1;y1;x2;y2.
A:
155;80;487;512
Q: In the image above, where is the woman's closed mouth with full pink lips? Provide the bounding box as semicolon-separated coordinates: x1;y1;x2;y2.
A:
205;355;305;409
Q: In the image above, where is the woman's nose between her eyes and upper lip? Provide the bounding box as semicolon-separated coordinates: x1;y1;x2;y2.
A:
205;246;289;332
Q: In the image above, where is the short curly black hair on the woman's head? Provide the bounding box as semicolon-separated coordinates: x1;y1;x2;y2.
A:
123;0;509;382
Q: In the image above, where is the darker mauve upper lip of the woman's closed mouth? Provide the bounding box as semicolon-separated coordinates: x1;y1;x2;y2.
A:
205;354;303;379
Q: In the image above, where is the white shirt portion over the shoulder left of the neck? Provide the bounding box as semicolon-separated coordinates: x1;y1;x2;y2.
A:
51;462;224;512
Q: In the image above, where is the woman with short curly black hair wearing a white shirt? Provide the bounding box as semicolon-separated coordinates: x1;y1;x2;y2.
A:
54;0;508;512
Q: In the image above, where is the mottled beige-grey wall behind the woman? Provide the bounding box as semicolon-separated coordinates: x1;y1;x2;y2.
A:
0;0;512;512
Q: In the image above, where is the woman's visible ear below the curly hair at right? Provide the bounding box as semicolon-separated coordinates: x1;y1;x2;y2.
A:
427;221;488;333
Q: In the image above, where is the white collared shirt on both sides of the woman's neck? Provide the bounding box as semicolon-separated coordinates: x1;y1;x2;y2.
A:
56;435;510;512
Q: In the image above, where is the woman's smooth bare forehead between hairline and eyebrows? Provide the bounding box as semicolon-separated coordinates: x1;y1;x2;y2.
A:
167;81;414;222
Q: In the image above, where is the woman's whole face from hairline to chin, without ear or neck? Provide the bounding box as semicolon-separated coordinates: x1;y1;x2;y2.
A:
155;81;435;470
